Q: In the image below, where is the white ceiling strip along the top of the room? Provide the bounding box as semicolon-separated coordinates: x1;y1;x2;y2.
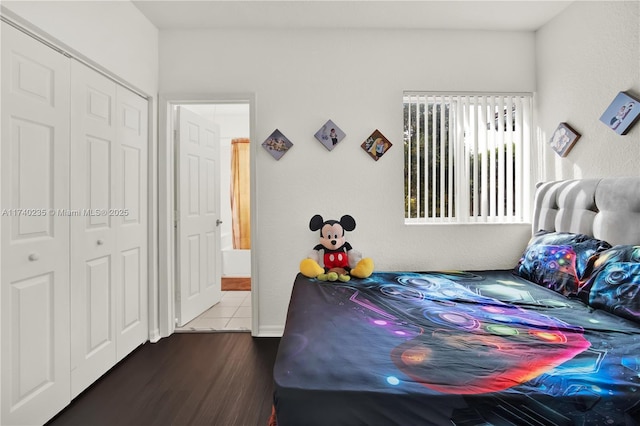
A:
133;0;572;31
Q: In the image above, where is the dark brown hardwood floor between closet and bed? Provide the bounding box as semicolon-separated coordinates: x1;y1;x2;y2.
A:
47;333;280;426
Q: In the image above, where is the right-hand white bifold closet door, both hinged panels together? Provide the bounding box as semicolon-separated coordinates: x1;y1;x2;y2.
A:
70;61;148;397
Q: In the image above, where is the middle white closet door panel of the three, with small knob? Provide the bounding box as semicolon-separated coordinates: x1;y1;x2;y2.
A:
70;61;120;397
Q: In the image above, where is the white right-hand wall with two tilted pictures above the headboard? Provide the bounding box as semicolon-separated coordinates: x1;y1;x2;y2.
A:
536;1;640;180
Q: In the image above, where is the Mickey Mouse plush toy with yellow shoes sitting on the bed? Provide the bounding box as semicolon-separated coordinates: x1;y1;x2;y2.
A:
300;214;373;282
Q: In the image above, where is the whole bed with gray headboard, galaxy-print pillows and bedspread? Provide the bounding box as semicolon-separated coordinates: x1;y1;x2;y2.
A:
271;177;640;426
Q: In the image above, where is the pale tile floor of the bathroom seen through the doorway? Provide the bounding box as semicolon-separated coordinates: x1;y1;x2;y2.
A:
176;291;251;333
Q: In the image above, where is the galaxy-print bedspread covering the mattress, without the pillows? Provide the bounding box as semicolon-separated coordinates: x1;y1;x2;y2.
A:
274;271;640;426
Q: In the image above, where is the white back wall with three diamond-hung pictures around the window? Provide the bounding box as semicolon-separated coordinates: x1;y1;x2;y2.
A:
160;30;535;335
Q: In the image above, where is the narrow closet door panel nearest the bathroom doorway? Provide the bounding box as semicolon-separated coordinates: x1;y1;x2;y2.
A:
111;86;149;361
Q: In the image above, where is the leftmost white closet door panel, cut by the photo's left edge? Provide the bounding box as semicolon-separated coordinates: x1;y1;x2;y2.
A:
0;23;70;425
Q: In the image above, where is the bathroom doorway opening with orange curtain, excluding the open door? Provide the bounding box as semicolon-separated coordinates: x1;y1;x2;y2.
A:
173;101;252;332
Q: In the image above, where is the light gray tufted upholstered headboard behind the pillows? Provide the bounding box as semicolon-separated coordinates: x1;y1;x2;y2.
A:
533;177;640;245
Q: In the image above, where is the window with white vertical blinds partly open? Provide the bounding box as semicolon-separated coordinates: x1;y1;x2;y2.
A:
404;92;532;223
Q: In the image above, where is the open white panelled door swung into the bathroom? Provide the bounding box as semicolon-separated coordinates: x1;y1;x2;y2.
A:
175;107;222;326
